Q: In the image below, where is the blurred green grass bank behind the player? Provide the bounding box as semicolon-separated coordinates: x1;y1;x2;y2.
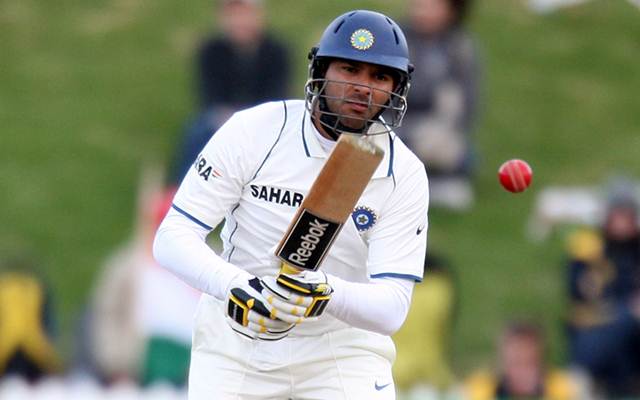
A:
0;0;640;371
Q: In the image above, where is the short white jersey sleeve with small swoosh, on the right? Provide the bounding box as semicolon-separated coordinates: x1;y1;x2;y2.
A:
367;163;429;282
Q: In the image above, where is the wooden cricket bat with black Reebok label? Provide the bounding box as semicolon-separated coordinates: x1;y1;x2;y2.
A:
276;134;384;271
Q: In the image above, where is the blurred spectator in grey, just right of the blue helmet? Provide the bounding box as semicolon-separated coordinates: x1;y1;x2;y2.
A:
397;0;480;210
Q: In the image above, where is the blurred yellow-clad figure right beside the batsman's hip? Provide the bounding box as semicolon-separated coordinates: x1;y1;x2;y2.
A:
393;255;456;392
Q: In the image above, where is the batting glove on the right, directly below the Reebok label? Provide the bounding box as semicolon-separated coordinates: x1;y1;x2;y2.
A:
262;264;333;324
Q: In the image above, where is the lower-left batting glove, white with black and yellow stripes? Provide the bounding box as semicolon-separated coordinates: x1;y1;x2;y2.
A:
225;277;294;340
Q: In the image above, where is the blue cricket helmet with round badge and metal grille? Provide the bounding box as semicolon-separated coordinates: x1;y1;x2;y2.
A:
305;10;413;137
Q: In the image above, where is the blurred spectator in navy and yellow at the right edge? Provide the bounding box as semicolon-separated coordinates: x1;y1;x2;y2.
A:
568;190;640;397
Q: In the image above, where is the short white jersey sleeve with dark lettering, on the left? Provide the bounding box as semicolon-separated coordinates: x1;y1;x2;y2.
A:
173;114;255;230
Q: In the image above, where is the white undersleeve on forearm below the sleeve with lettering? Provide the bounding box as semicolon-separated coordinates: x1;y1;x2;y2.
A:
153;209;251;300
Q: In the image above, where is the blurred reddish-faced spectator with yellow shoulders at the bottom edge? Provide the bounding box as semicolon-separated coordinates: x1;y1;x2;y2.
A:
465;322;588;400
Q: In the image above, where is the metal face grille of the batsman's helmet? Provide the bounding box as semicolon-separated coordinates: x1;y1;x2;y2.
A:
305;78;408;135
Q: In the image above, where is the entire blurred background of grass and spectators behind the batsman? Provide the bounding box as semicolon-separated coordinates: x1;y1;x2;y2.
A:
0;0;640;400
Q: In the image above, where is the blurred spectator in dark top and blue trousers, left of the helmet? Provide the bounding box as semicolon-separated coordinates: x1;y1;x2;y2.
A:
173;0;290;183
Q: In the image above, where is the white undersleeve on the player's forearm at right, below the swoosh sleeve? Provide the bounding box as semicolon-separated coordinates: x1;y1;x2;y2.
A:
327;275;415;336
